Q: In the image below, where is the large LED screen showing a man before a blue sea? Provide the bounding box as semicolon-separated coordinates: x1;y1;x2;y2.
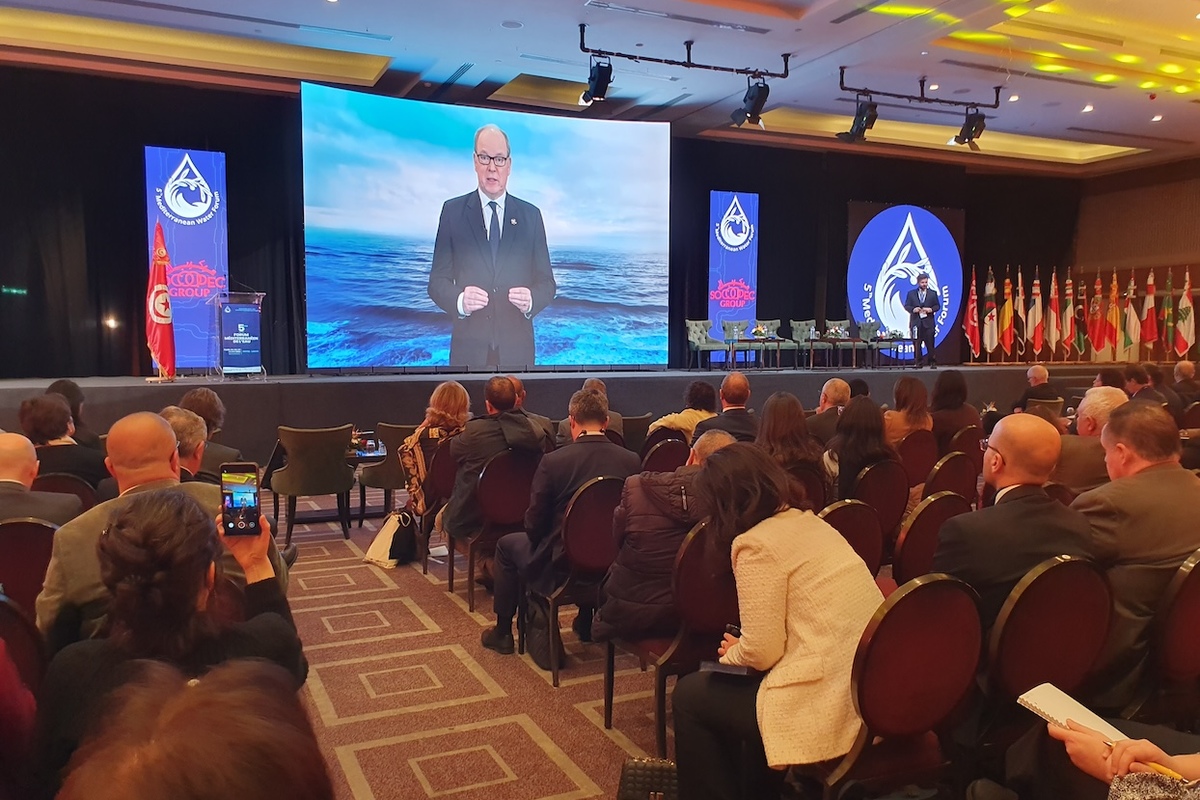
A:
301;84;670;369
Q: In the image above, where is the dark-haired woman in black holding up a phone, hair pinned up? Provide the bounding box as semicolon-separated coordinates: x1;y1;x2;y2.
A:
36;492;308;796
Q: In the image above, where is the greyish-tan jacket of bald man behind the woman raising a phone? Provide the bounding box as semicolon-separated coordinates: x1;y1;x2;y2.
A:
35;481;288;638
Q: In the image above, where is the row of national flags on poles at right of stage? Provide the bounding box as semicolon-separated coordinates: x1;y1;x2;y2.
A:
962;266;1196;361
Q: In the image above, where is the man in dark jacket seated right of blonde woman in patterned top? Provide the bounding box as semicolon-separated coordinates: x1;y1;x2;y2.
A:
436;375;548;544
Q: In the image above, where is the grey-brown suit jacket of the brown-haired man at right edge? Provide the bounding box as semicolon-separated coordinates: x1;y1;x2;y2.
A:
1072;463;1200;709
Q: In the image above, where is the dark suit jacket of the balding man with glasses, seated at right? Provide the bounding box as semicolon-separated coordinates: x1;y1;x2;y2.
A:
934;486;1092;628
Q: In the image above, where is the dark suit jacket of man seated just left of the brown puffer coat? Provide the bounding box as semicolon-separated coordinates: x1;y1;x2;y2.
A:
526;434;642;591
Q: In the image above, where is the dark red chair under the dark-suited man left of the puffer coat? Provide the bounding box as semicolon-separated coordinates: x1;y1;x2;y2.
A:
517;475;625;688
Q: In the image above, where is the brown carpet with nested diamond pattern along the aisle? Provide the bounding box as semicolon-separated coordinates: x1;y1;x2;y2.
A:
280;491;654;800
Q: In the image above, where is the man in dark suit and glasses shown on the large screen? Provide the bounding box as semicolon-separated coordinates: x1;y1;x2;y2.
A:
430;125;558;367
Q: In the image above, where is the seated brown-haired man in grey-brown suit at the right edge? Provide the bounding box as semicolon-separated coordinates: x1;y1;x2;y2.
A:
1072;402;1200;710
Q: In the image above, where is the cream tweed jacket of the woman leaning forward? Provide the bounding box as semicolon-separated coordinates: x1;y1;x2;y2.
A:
721;509;883;768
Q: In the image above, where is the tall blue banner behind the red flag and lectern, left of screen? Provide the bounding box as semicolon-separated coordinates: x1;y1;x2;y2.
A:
146;146;229;369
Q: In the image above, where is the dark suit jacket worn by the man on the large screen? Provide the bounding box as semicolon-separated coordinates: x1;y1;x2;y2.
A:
430;190;558;366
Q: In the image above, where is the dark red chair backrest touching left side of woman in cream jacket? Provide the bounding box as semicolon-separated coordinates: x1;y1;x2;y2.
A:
671;522;740;638
